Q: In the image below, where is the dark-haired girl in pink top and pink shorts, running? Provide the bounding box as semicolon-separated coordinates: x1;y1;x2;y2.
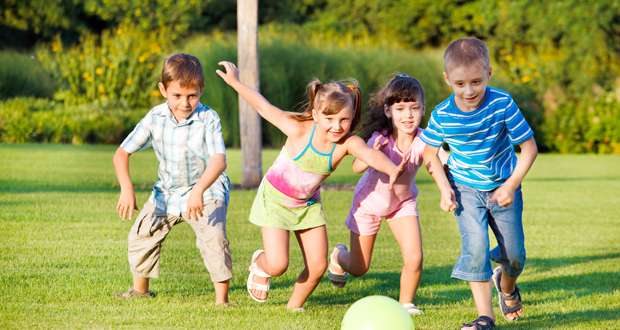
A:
328;73;448;315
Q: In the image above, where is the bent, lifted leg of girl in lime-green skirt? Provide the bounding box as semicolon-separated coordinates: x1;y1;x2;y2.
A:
250;227;289;300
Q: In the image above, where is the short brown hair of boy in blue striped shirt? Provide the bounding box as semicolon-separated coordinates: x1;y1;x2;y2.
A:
443;38;491;74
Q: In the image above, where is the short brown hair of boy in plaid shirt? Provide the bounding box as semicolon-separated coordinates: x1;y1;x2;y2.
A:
161;54;205;88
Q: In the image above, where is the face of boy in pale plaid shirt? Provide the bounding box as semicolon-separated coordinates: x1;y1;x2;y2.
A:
158;80;204;122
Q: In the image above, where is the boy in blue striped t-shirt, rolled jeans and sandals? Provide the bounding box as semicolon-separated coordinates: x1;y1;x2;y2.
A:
421;38;538;329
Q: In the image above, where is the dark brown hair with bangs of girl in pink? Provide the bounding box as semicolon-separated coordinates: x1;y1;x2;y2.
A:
362;73;425;141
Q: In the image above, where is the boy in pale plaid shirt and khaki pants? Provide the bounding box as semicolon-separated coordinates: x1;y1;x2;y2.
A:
114;54;232;306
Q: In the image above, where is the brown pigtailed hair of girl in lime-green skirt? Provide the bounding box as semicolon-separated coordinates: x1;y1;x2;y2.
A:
293;78;362;132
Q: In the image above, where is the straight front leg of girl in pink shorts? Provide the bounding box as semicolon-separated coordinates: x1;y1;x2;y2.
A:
388;216;423;304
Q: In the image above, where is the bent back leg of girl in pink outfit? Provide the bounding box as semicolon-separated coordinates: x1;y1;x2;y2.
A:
330;232;377;277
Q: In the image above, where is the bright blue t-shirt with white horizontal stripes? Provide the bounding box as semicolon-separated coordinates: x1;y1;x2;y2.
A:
420;87;534;190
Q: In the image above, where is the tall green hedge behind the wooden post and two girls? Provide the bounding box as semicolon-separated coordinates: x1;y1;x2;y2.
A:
185;30;450;147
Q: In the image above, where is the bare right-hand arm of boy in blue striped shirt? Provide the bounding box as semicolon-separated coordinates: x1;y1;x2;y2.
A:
489;137;538;207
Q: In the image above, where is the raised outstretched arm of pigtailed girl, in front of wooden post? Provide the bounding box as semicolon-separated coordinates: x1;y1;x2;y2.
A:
215;61;300;136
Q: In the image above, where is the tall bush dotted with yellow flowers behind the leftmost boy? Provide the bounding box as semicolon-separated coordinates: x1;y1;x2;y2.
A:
37;25;170;107
